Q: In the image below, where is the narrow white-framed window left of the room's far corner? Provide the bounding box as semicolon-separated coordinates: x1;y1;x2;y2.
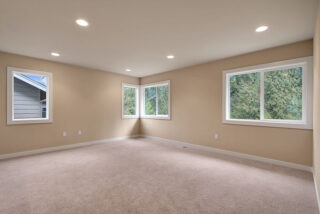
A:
122;84;139;118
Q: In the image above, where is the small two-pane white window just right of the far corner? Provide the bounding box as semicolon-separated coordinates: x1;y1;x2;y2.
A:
141;81;170;119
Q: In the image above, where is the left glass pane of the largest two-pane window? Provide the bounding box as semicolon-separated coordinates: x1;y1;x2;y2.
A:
230;72;260;120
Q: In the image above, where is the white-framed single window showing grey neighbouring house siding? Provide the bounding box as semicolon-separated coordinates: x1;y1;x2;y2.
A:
7;67;52;124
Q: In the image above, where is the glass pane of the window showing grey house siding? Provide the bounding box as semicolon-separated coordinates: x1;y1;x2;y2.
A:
13;72;48;119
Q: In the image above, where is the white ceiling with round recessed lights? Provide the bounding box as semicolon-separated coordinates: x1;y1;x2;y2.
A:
0;0;317;77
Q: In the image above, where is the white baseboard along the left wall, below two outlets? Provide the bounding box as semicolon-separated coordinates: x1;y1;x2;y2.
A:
0;135;140;160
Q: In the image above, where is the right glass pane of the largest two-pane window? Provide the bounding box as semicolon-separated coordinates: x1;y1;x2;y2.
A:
264;67;302;120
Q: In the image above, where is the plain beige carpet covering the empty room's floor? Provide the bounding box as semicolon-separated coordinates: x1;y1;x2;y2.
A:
0;139;317;214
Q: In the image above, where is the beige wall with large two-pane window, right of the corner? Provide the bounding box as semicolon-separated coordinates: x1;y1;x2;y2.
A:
140;40;313;166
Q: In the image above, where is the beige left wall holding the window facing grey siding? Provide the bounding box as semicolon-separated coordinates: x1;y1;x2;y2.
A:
0;52;139;154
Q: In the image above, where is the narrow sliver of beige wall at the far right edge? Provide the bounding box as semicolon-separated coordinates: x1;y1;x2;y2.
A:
313;4;320;197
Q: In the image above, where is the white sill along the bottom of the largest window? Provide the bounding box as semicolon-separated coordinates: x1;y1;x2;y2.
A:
222;119;312;129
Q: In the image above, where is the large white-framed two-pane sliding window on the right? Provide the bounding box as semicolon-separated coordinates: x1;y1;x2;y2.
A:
223;57;312;129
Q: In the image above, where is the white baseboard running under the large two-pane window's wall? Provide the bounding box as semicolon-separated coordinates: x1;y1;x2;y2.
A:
141;135;312;172
